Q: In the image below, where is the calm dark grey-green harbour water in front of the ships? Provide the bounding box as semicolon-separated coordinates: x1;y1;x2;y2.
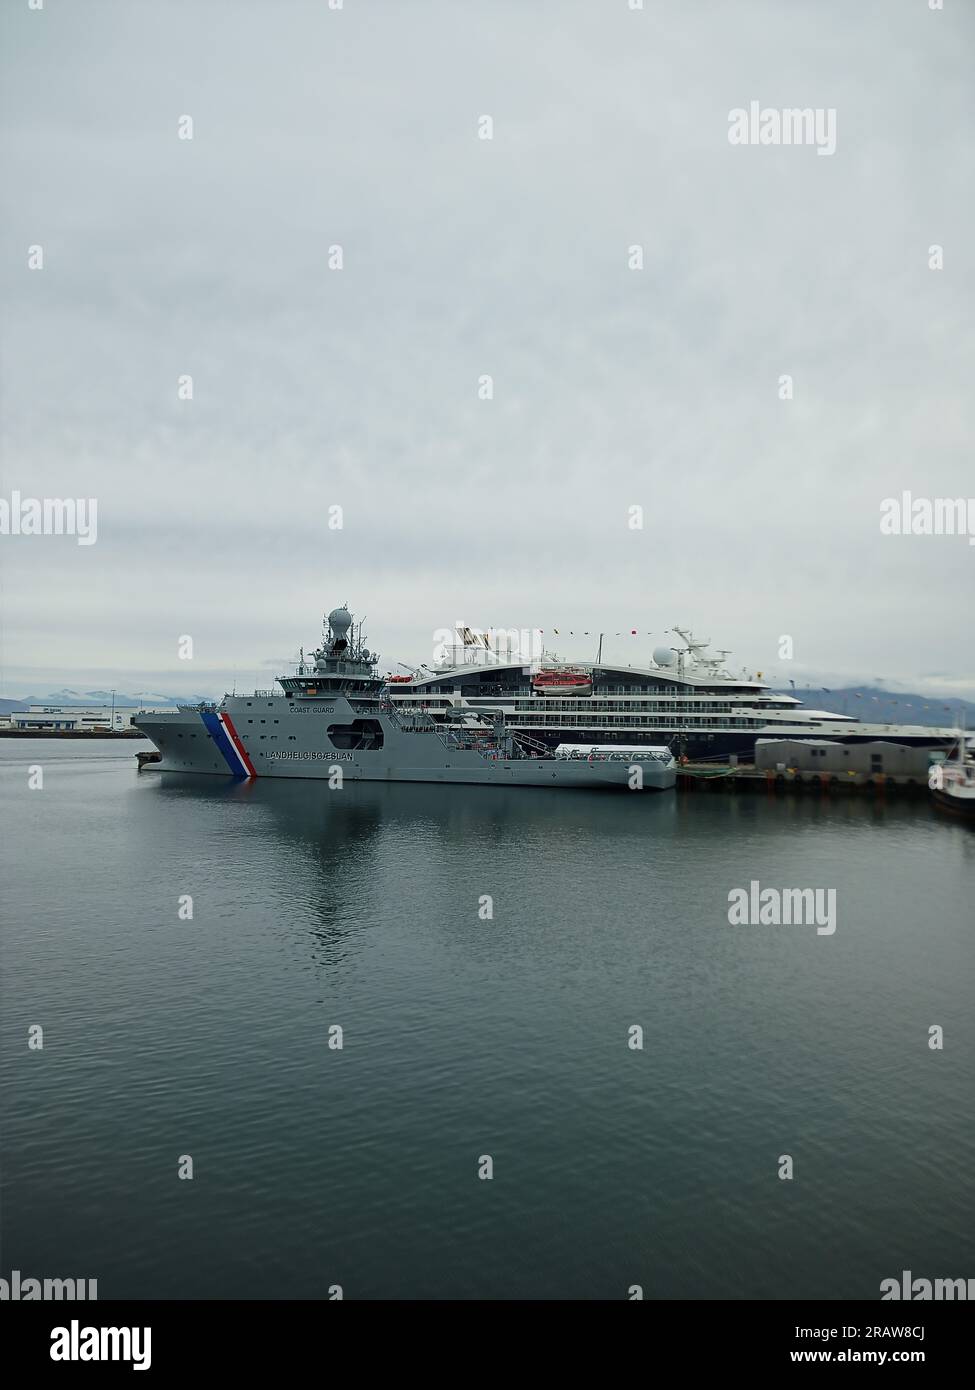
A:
0;741;975;1298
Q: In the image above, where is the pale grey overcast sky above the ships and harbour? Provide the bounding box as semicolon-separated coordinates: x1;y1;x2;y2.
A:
0;0;975;696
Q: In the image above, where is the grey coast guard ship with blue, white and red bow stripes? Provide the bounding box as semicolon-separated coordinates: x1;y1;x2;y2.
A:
132;607;677;791
